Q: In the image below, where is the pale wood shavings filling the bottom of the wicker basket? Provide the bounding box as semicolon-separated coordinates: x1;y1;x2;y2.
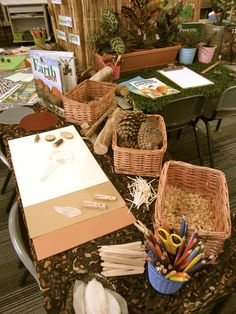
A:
163;184;215;231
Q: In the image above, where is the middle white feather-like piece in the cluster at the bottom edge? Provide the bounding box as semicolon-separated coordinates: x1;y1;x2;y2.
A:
85;278;108;314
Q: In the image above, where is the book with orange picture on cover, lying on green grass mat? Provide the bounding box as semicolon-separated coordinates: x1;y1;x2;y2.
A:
130;77;179;99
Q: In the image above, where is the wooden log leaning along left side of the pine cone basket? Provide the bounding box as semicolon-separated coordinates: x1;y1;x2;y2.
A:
93;108;121;155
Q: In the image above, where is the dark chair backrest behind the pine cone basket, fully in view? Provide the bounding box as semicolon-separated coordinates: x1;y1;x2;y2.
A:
158;95;205;128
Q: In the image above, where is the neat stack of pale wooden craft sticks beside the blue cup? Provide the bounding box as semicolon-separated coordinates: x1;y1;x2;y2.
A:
99;241;146;277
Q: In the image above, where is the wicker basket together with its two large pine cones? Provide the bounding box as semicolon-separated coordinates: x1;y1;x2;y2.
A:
112;110;167;177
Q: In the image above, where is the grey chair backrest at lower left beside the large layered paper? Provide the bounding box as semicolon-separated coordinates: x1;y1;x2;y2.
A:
8;201;40;287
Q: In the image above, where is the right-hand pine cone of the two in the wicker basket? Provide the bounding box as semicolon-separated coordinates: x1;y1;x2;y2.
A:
138;121;163;150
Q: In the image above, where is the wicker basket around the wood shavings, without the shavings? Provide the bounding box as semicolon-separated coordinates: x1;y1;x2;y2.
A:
155;161;231;256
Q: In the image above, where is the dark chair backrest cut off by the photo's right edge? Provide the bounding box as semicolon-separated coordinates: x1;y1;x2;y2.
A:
214;86;236;119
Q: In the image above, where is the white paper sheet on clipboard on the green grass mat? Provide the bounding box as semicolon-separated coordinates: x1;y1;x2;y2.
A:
159;67;214;88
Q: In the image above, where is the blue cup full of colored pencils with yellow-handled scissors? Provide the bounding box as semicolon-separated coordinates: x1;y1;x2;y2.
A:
135;217;215;294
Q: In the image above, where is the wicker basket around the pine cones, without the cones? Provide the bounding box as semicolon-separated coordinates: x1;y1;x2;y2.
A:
112;115;167;177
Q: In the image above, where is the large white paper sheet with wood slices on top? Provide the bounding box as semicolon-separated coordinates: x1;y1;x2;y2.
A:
9;126;108;207
